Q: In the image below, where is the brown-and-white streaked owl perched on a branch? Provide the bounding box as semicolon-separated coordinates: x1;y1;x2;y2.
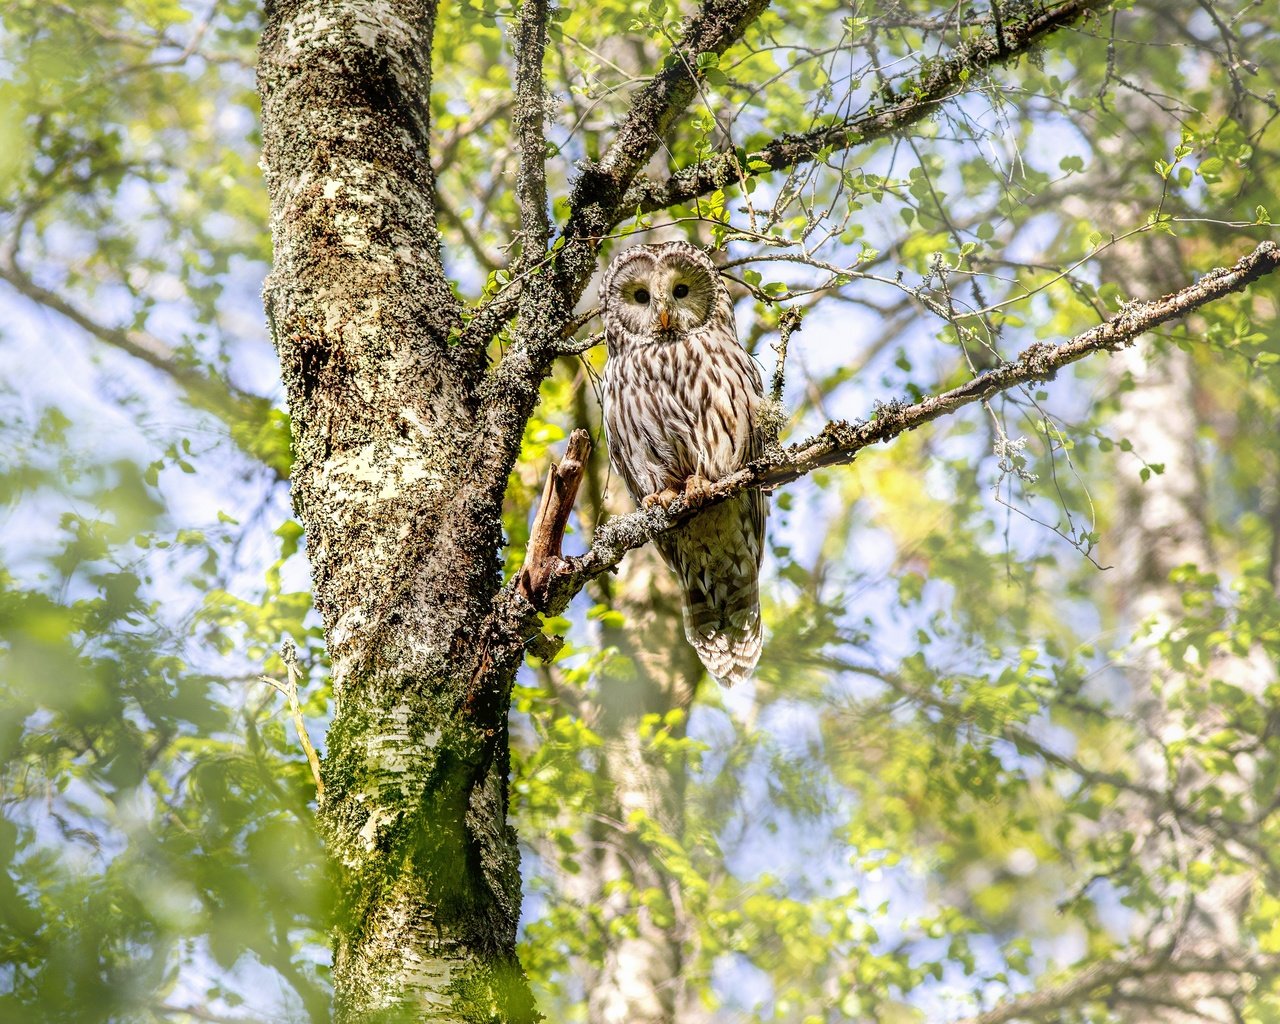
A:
600;242;765;686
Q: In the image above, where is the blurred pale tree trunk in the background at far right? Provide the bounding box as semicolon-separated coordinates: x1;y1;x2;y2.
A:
1108;238;1271;1024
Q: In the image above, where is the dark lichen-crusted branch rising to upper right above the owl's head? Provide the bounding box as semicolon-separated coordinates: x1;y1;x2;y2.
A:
619;0;1111;213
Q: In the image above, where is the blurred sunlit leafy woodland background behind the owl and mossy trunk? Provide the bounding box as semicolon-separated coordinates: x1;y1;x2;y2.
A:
0;0;1280;1024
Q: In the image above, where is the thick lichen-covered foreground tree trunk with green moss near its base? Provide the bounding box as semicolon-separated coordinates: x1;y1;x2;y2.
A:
259;0;536;1021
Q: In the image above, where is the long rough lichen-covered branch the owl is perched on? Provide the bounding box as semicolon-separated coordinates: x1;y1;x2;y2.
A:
539;242;1280;613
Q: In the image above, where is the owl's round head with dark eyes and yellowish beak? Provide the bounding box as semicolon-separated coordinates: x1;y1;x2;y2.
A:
600;242;727;348
